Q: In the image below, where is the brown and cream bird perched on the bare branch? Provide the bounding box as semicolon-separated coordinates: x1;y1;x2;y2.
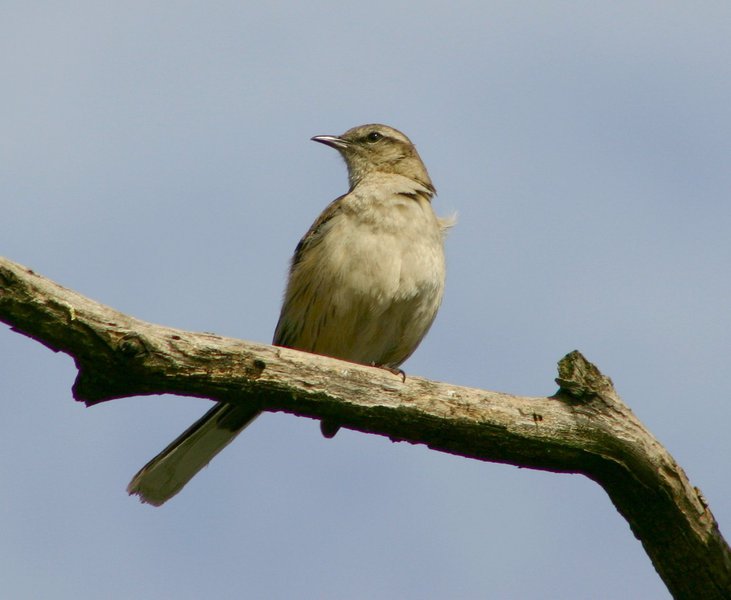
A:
127;124;454;506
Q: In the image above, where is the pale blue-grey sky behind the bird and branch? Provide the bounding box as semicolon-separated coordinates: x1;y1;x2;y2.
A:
0;0;731;600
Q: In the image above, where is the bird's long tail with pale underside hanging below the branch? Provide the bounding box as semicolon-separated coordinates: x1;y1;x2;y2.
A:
127;402;260;506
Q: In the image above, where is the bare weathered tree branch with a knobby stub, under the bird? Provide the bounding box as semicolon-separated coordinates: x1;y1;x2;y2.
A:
0;258;731;600
